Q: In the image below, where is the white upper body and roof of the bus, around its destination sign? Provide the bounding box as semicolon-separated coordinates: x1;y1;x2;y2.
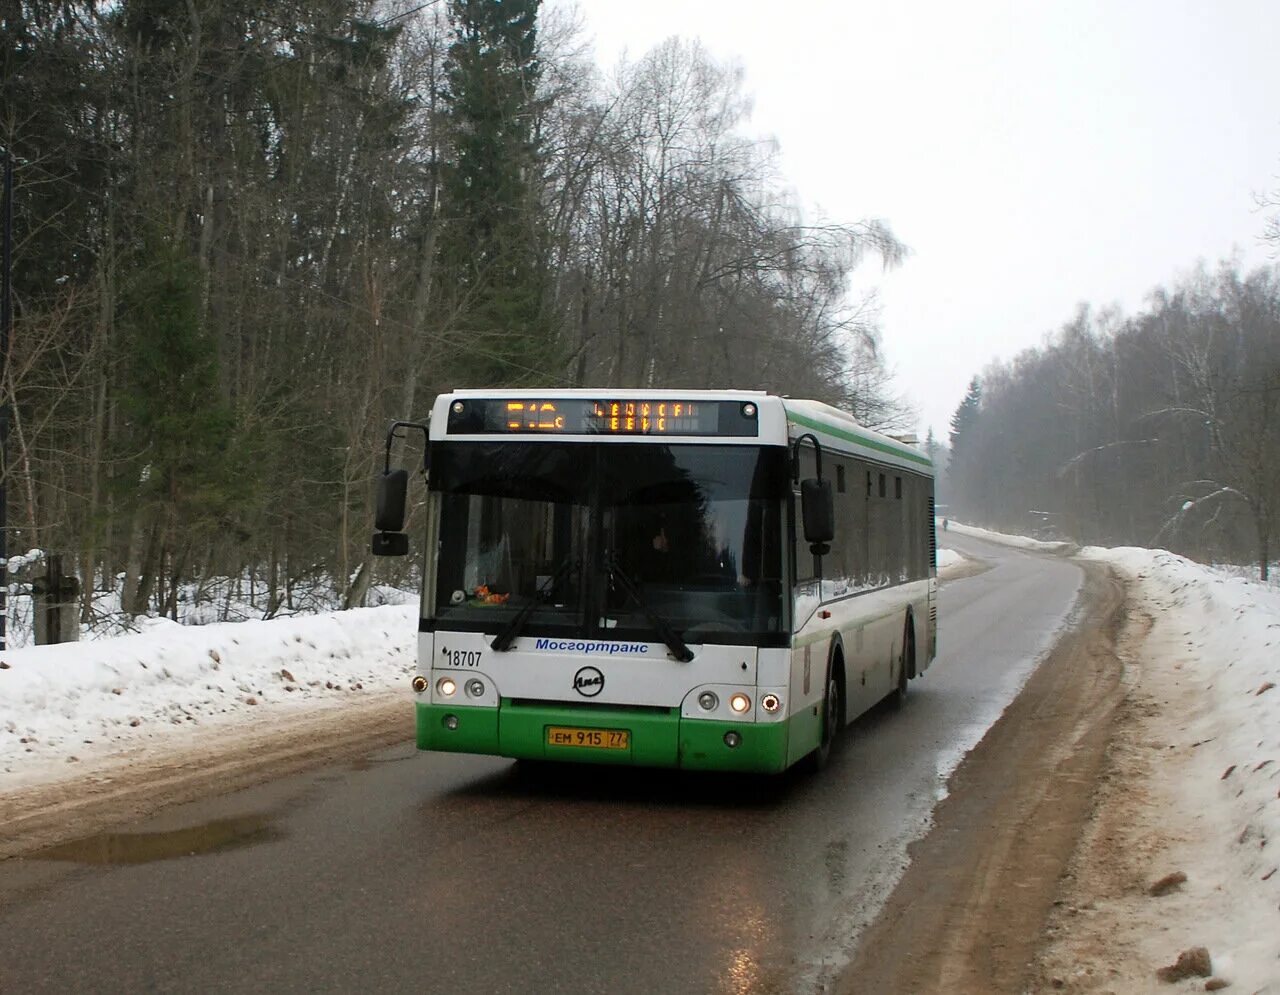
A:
430;387;933;474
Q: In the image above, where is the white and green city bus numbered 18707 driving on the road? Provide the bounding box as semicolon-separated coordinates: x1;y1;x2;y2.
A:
372;389;937;773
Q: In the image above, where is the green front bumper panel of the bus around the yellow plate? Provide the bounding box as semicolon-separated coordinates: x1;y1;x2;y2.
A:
417;699;790;773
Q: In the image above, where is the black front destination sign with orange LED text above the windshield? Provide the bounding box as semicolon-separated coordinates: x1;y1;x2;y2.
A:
448;398;759;437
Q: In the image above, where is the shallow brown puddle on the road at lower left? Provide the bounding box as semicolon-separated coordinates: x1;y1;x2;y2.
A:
29;816;284;864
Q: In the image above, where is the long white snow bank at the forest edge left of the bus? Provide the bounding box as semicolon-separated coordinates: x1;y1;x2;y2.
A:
0;604;417;790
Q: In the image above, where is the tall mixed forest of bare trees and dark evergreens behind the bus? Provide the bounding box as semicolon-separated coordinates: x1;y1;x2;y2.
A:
0;0;910;622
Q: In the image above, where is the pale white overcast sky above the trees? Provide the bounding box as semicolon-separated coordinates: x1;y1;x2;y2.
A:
547;0;1280;438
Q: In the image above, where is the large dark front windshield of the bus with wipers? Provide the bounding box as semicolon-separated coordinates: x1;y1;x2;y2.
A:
431;442;790;643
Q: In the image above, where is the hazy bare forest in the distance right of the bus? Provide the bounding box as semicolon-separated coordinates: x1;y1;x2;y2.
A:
946;259;1280;580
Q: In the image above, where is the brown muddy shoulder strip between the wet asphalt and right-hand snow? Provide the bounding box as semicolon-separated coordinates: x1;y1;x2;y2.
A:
835;563;1126;992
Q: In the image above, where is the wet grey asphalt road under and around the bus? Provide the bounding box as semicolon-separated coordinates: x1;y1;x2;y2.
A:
0;533;1082;995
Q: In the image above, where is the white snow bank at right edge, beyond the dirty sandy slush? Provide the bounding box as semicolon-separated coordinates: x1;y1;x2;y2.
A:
1080;547;1280;991
